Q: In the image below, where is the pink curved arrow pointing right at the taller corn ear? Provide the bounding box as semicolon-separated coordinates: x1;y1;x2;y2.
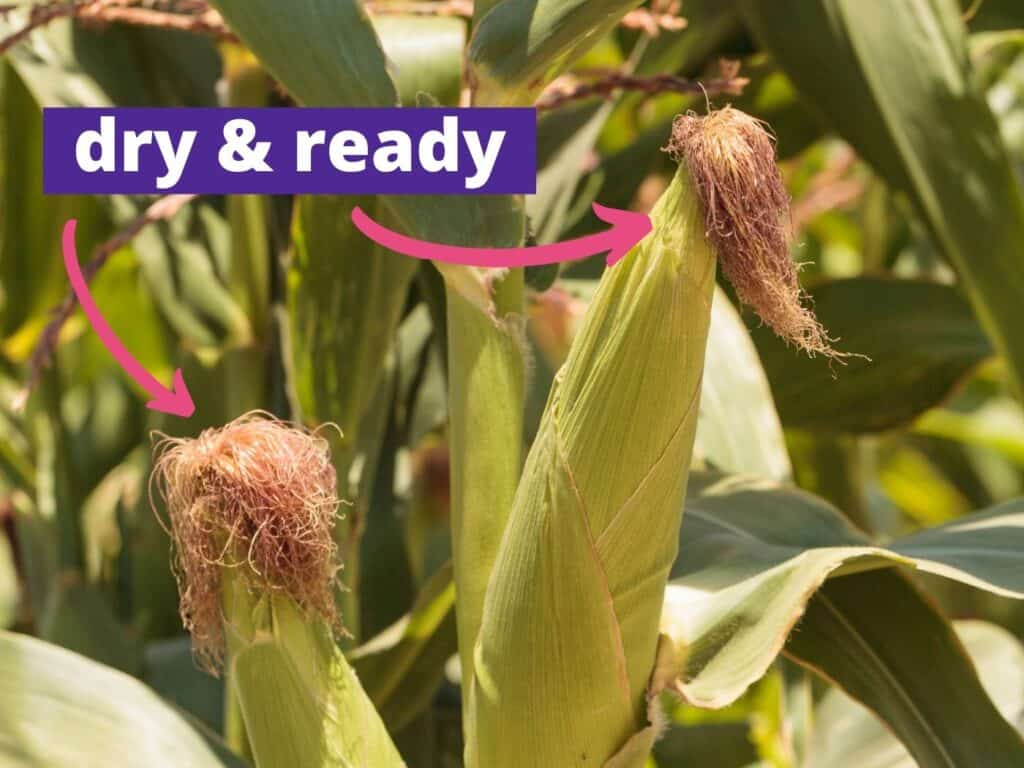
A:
352;203;651;267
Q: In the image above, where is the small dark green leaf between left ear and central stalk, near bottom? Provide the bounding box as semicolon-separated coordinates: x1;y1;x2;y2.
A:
349;566;457;733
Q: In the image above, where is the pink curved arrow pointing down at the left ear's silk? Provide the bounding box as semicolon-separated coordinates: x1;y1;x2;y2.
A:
63;219;196;419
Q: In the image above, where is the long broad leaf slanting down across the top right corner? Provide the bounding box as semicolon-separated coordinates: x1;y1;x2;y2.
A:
740;0;1024;391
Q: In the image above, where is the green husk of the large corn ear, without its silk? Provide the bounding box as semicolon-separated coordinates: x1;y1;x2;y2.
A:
468;167;716;768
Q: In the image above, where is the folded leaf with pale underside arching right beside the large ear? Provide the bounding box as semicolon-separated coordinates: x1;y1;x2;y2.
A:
662;473;1024;708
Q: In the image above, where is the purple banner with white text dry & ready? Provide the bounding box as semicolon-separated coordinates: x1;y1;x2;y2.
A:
43;108;537;195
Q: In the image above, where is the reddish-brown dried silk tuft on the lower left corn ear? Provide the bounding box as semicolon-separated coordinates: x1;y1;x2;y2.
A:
151;412;343;672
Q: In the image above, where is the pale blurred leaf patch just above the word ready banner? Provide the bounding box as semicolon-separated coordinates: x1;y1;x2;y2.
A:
374;14;466;106
